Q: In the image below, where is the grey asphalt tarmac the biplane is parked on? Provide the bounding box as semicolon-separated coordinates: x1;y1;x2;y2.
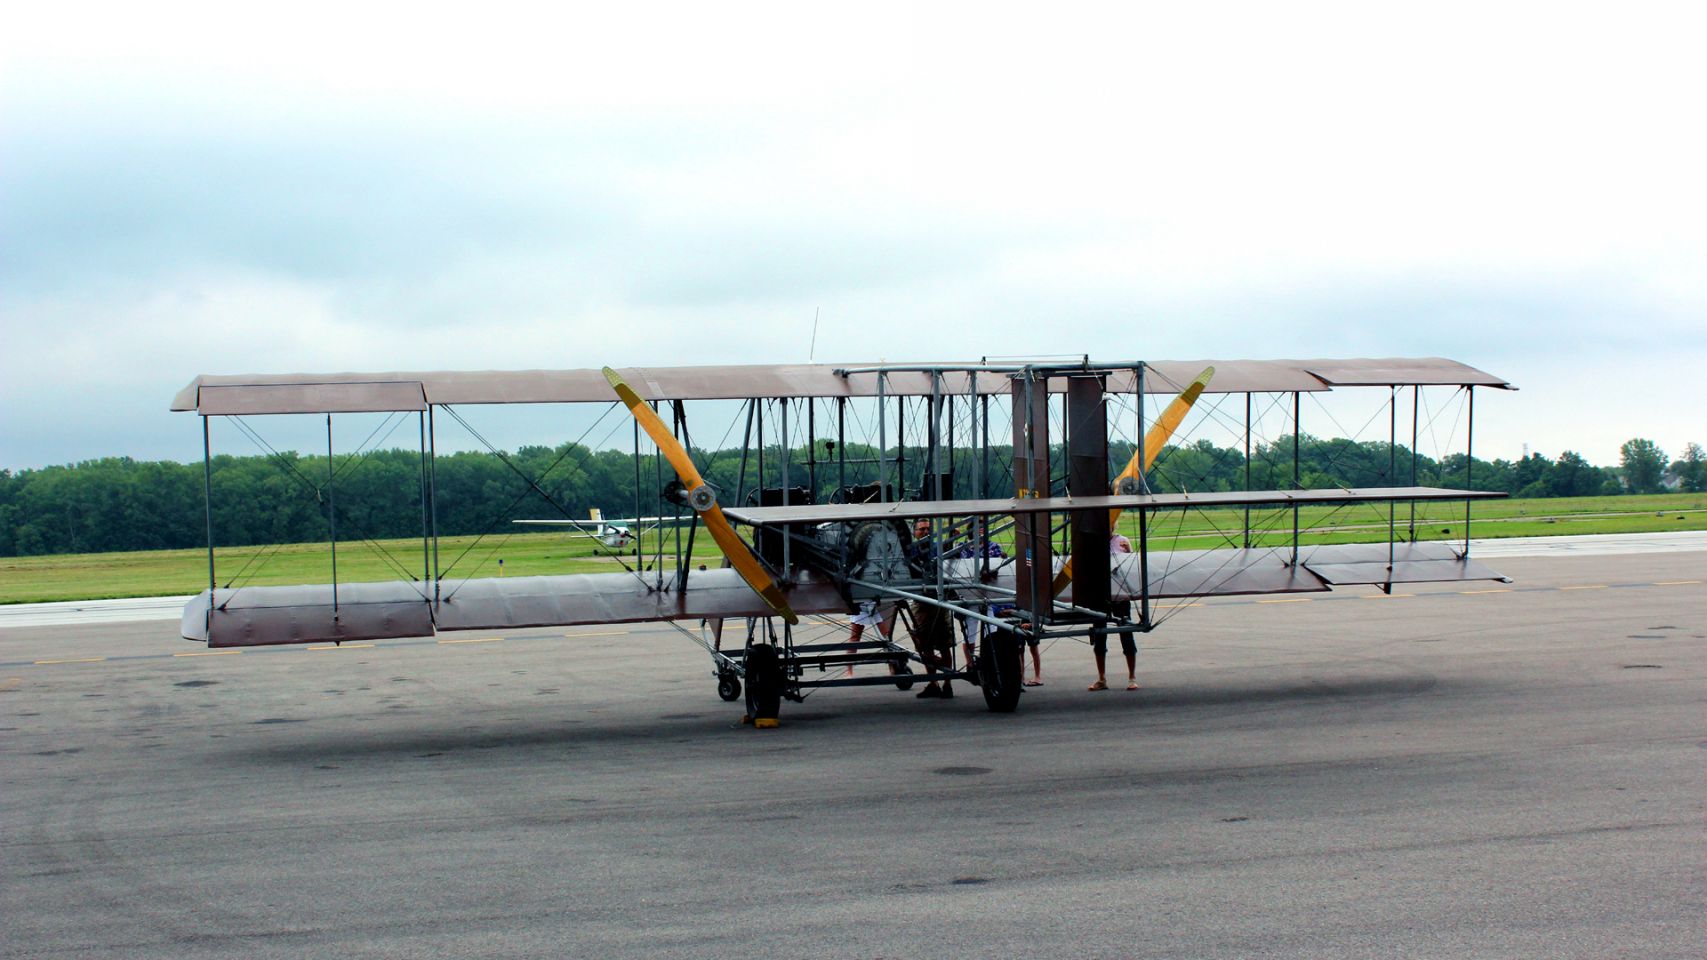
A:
0;552;1707;958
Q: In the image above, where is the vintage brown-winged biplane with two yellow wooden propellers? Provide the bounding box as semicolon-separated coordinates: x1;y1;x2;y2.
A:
172;357;1512;726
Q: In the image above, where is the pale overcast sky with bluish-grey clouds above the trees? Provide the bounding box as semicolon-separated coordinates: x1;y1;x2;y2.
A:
0;2;1707;468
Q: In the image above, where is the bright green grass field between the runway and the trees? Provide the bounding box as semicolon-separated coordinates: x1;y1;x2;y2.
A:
0;494;1707;603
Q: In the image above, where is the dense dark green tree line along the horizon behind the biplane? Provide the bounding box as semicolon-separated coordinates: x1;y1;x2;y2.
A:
0;436;1707;557
